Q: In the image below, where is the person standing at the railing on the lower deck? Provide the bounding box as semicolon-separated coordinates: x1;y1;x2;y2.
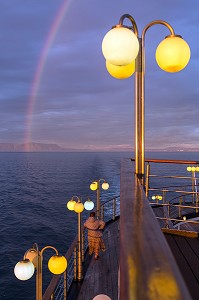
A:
84;212;106;259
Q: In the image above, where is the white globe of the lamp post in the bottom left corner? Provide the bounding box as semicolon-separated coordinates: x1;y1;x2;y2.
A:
14;259;35;280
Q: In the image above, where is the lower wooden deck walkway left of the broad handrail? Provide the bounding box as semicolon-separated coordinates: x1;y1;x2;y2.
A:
77;220;119;300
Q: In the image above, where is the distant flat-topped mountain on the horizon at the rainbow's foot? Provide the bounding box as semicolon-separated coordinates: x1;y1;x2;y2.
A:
0;143;66;152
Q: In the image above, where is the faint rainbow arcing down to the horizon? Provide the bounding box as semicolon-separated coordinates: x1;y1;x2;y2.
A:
24;0;72;152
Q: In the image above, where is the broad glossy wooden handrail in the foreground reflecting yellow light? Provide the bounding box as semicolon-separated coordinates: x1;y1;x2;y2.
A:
120;159;191;300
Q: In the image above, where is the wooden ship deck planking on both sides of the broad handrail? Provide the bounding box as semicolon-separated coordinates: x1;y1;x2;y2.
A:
67;208;199;300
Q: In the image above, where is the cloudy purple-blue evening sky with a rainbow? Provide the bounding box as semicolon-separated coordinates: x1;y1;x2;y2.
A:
0;0;199;151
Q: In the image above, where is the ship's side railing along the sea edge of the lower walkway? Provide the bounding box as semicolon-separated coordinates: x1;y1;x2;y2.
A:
42;196;120;300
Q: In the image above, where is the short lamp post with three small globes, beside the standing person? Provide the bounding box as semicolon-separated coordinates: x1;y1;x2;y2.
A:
66;196;94;281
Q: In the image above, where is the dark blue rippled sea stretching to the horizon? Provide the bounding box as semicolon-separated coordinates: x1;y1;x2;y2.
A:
0;152;199;300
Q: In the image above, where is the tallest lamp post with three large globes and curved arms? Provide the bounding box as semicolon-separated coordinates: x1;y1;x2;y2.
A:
102;14;190;184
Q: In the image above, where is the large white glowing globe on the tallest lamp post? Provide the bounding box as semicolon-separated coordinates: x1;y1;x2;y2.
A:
102;26;139;66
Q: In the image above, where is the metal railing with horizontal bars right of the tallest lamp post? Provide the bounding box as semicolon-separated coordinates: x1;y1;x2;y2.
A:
145;159;199;230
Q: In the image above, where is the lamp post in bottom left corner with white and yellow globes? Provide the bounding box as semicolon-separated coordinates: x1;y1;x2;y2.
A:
14;243;67;300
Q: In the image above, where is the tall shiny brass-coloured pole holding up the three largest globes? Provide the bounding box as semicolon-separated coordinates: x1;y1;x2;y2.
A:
135;38;145;185
